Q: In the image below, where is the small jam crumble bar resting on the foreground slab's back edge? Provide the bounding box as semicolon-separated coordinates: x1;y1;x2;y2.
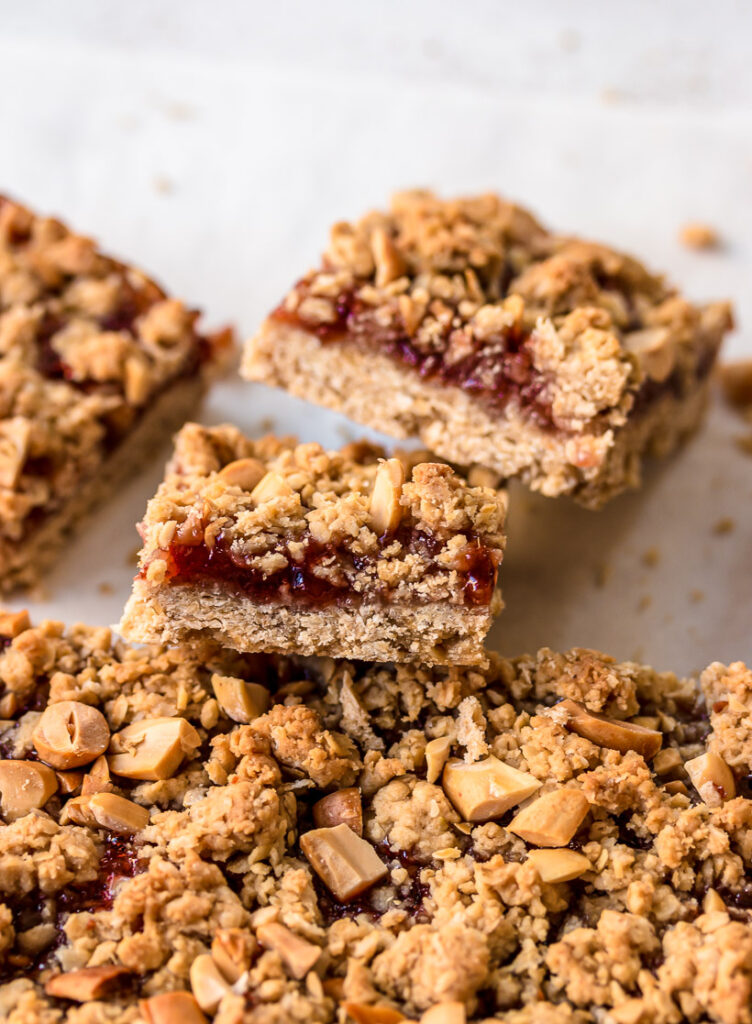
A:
121;424;506;664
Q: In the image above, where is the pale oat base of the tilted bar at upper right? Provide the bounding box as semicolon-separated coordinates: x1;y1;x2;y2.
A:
248;318;709;508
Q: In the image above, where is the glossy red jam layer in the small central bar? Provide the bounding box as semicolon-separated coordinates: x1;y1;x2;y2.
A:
145;530;498;607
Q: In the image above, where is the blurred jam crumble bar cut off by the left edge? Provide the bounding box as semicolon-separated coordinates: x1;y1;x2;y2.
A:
0;196;231;592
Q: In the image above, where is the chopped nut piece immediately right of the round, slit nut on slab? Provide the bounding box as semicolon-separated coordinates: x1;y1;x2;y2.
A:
109;718;201;782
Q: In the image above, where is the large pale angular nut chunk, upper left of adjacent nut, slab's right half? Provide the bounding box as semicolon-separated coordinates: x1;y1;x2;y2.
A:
442;755;541;821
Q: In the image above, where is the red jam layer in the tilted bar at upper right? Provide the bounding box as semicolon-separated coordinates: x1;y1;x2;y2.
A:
271;282;554;428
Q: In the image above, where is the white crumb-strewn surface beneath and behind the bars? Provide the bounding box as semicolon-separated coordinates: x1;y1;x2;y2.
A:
0;6;752;671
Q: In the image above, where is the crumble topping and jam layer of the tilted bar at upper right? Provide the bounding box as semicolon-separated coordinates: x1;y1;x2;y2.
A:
271;191;732;433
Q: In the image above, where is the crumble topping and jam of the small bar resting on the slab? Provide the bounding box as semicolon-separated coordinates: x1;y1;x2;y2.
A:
133;424;506;606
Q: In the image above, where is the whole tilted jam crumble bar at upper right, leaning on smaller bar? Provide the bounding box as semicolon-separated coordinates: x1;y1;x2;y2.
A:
243;191;732;507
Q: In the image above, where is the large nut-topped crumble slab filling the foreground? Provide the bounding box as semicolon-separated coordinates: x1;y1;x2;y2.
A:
0;615;752;1024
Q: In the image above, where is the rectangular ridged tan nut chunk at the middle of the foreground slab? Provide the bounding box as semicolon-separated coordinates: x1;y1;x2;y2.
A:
300;824;388;903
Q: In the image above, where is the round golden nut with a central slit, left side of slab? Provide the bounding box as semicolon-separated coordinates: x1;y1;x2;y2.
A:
32;700;110;771
